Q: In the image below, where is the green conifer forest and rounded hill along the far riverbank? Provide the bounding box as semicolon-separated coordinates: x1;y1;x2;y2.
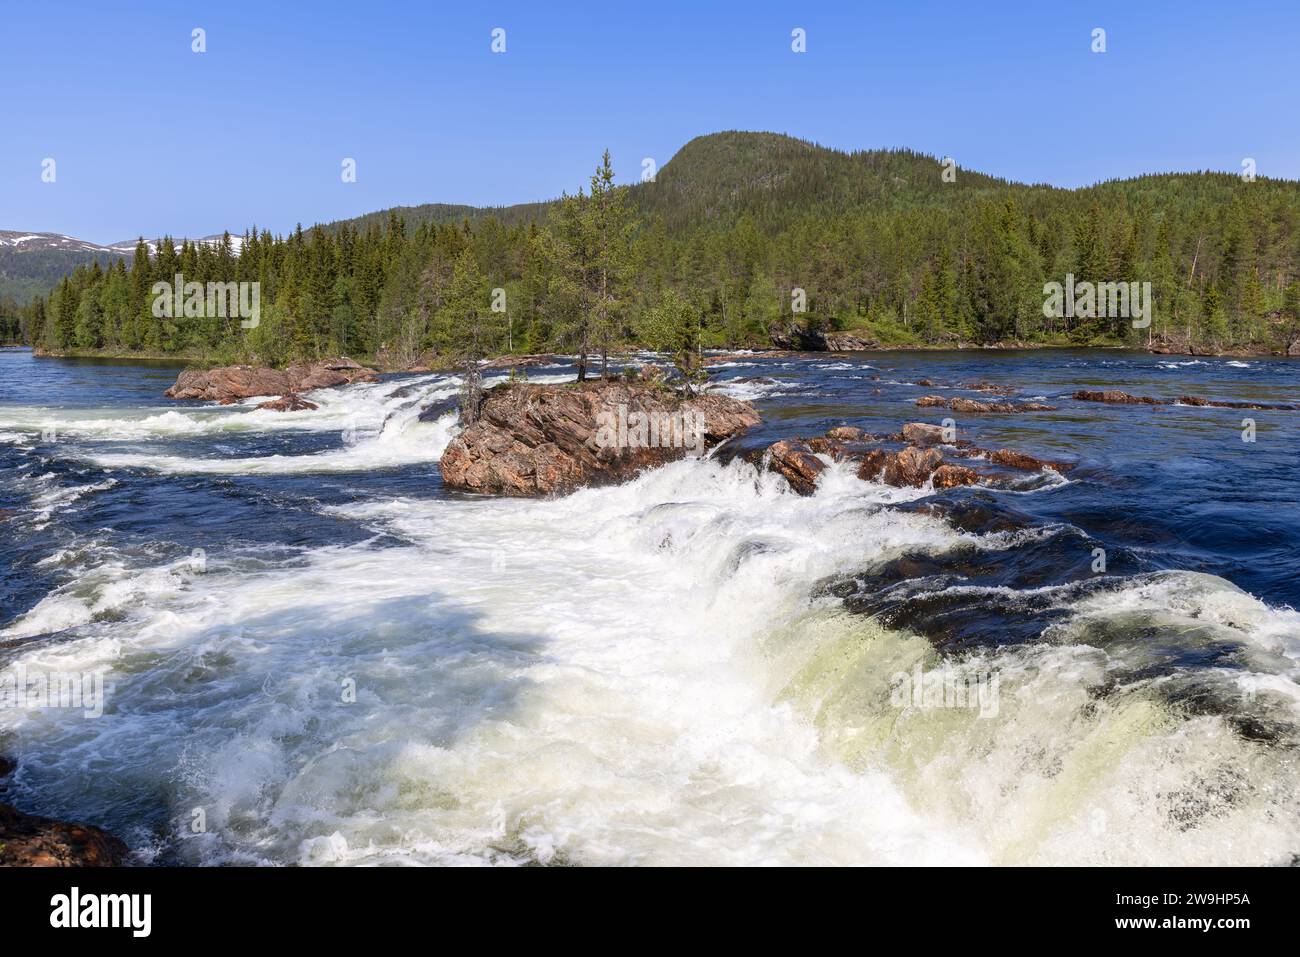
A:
10;133;1300;363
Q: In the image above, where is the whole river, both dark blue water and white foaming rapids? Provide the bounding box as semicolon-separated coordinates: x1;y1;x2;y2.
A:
0;350;1300;865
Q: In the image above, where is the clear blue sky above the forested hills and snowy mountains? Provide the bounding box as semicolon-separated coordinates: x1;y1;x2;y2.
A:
0;0;1300;242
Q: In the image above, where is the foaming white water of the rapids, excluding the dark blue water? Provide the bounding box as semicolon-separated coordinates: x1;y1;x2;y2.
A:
0;377;1300;865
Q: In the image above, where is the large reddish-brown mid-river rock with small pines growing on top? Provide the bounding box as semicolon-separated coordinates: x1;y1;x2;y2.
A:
442;380;761;495
